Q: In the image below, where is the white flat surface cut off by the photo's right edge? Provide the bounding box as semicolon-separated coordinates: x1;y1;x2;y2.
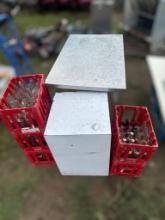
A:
147;56;165;123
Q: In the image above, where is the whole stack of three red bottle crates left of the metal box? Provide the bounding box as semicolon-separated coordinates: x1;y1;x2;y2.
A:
0;74;54;165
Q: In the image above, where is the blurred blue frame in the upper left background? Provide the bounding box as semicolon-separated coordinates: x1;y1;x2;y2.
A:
0;14;33;76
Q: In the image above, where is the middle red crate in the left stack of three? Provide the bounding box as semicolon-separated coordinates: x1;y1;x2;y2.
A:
15;132;49;152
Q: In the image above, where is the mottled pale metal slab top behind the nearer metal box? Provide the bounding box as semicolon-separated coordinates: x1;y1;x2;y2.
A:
46;35;126;91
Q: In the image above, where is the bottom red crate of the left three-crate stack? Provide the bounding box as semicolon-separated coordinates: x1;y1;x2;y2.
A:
25;150;55;165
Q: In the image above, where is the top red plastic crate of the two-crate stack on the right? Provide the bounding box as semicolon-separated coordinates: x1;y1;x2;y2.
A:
111;105;158;163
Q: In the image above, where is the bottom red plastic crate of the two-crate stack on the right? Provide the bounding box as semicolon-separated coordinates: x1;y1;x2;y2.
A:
110;161;145;177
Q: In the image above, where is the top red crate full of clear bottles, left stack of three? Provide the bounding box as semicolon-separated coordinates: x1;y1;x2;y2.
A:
0;74;51;134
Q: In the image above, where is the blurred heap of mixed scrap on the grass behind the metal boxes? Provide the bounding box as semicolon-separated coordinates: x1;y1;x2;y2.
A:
23;18;87;59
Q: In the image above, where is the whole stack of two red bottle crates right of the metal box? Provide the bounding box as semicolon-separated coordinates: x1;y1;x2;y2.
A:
110;105;158;176
